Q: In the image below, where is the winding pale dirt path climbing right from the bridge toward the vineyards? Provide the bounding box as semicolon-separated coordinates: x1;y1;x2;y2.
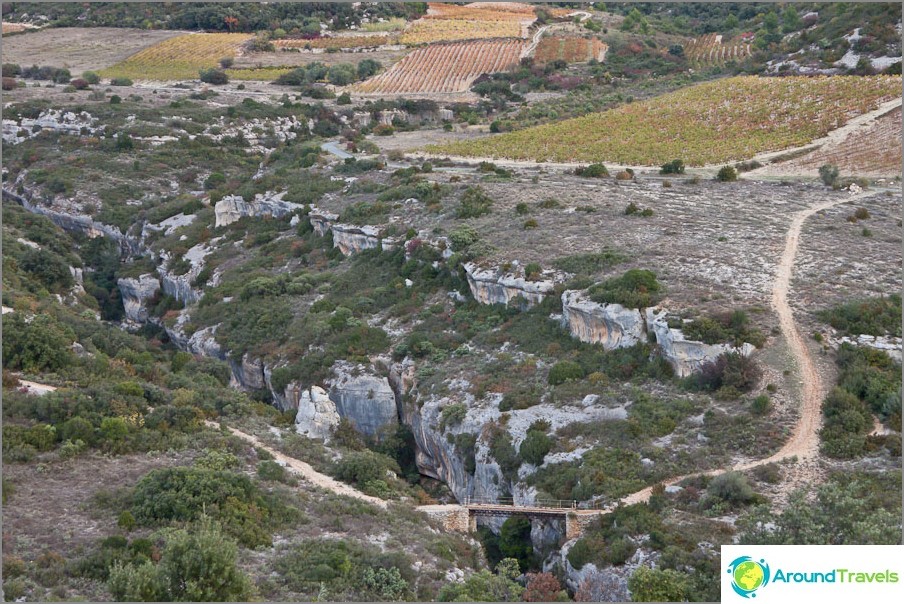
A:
613;191;876;508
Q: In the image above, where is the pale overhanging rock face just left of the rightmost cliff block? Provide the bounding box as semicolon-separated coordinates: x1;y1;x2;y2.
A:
562;291;647;350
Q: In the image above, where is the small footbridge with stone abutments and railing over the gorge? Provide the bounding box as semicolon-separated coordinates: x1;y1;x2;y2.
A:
417;499;611;540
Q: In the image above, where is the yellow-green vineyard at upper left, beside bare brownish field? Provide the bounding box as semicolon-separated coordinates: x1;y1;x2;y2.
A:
101;34;252;81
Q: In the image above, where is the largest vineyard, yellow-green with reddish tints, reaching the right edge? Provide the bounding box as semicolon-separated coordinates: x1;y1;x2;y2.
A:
428;76;901;166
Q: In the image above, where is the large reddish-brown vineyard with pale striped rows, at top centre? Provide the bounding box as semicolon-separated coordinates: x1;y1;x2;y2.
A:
355;40;524;94
